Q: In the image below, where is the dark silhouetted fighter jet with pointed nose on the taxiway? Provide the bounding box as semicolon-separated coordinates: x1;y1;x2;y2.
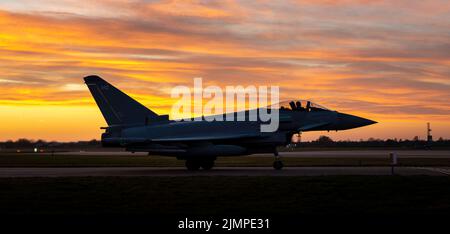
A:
84;75;376;170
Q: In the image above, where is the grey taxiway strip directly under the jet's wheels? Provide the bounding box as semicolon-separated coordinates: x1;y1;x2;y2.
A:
0;167;450;177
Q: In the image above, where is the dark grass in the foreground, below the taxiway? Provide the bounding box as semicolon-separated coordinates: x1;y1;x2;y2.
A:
0;176;450;215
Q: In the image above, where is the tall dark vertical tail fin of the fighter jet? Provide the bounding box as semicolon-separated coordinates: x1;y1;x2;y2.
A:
84;75;160;126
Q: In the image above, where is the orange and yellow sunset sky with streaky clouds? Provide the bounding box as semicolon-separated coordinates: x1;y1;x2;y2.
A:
0;0;450;141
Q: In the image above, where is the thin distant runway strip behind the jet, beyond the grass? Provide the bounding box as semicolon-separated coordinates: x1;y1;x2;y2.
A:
55;150;450;159
